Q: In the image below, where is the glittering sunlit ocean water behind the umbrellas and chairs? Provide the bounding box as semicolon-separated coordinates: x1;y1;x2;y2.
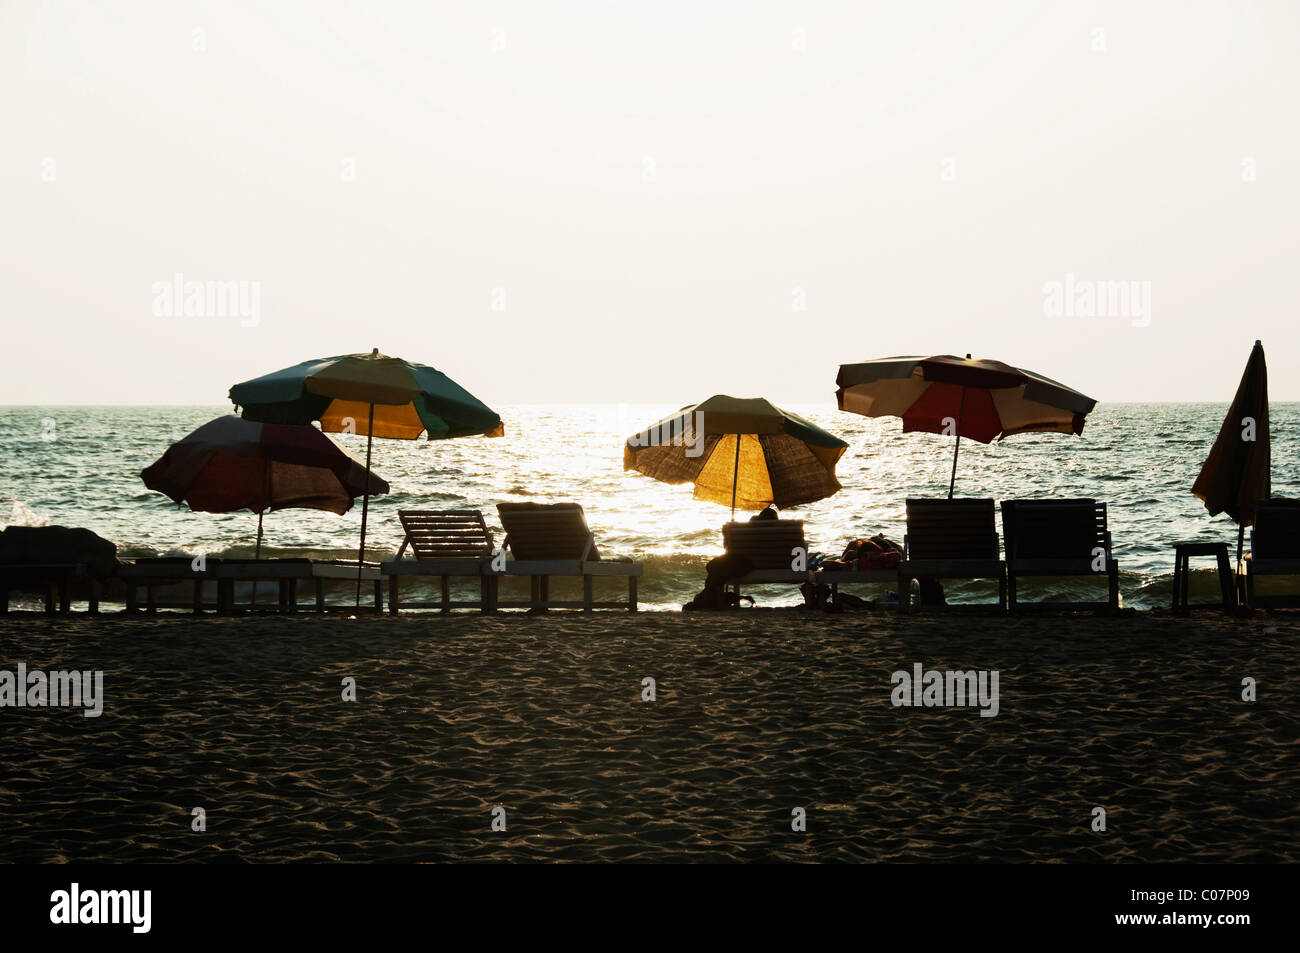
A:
0;403;1300;608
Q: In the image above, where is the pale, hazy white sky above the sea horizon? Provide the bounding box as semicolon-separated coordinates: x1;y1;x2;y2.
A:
0;0;1300;406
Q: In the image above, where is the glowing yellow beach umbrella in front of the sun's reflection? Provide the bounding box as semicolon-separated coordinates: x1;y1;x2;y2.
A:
623;394;849;519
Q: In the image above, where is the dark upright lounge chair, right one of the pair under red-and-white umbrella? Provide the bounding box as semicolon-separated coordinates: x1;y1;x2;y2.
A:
1002;499;1119;612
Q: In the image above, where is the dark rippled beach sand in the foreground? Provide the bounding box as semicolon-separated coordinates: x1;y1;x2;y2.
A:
0;610;1300;862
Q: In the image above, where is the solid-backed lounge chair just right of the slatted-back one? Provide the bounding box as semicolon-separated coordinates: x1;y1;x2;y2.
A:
494;503;641;612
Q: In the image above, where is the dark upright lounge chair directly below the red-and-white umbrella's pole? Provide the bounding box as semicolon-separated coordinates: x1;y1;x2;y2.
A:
898;499;1006;608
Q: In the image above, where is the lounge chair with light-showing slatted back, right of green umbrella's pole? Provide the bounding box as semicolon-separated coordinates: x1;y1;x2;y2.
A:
380;510;497;615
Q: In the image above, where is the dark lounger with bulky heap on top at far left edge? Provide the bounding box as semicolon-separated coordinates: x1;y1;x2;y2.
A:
0;527;117;615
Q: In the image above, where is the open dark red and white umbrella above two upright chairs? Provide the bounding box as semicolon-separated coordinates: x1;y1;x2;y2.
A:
836;354;1097;499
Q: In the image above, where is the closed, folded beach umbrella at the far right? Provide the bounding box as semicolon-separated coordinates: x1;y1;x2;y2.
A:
1192;341;1271;563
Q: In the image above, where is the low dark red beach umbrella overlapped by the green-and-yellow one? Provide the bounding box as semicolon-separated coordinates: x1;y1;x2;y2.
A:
140;415;389;559
